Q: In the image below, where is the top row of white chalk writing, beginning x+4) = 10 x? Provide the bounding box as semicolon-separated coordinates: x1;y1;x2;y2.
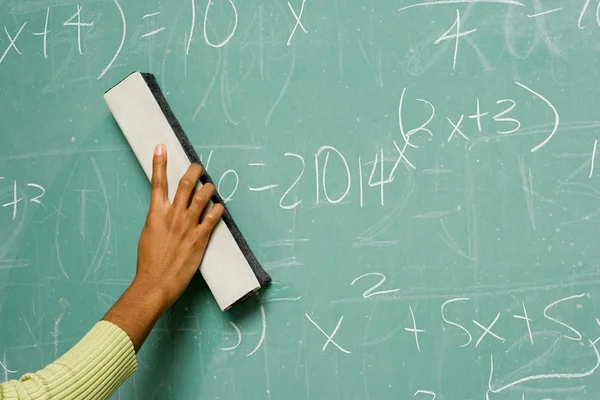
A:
0;0;600;79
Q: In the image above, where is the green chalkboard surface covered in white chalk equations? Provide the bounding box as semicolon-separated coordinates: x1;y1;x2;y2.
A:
0;0;600;400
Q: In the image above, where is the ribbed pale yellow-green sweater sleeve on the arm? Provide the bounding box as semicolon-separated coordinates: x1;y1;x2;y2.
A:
0;321;137;400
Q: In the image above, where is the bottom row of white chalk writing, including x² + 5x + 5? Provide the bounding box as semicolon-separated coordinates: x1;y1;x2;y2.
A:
220;280;600;400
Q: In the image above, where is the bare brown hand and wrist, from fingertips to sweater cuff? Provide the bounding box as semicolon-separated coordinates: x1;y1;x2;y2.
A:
103;145;224;353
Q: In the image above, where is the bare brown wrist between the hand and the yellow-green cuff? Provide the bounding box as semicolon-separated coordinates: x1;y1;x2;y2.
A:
102;278;168;353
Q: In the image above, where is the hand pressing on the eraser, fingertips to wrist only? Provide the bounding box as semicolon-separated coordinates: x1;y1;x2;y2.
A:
134;146;223;307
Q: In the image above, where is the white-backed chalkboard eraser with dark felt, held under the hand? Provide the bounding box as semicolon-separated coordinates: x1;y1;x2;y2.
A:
104;72;270;310
